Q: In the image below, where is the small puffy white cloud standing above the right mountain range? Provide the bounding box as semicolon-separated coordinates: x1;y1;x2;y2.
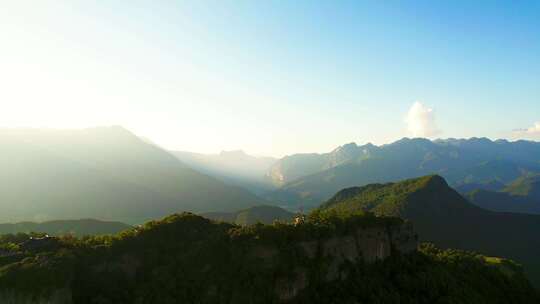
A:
405;101;440;137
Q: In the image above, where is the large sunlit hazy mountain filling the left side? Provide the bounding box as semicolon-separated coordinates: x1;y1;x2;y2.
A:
0;127;264;224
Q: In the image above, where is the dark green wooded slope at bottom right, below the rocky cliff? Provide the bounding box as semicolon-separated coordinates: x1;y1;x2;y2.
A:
297;243;540;304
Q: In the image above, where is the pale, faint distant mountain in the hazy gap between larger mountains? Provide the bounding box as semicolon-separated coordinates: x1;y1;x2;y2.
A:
171;151;277;194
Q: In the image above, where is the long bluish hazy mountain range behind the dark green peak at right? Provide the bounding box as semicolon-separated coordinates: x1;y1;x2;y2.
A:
266;138;540;209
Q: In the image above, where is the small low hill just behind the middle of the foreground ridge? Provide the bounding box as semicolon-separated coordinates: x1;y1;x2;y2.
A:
201;206;295;225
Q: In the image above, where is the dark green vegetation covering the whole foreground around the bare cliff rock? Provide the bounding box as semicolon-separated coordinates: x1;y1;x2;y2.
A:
0;211;539;304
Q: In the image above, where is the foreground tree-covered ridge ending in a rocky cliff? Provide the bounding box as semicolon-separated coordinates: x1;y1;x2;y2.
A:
0;214;417;304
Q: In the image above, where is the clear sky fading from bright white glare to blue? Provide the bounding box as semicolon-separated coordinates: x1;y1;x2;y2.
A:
0;0;540;157
